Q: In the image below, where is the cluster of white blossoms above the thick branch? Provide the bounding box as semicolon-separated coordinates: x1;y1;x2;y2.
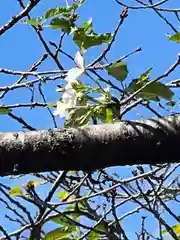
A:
53;52;84;118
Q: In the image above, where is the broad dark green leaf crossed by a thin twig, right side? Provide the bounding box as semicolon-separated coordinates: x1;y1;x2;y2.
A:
127;79;174;101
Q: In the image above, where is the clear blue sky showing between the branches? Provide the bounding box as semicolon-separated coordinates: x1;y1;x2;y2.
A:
0;0;180;238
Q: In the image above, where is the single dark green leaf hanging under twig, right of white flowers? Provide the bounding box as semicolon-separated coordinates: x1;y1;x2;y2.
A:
107;62;128;81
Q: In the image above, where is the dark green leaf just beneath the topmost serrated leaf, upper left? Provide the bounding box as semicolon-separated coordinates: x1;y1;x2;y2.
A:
49;18;74;33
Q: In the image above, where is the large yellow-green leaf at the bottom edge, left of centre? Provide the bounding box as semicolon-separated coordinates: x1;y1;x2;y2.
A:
44;226;76;240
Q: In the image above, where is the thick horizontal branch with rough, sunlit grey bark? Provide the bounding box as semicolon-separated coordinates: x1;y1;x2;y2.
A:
0;115;180;176
